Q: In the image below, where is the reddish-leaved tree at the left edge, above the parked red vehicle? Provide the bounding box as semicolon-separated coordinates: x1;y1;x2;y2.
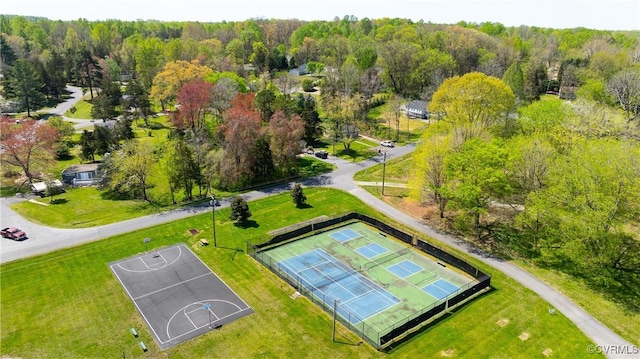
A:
0;117;60;183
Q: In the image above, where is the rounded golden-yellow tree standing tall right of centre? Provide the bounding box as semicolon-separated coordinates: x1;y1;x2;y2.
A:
430;72;515;141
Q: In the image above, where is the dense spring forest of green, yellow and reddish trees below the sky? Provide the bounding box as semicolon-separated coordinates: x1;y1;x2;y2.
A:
0;15;640;313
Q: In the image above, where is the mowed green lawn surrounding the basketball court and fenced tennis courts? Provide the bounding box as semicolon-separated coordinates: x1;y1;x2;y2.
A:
0;188;598;358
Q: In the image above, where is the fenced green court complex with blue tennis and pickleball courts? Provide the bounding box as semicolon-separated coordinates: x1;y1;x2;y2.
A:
252;214;484;348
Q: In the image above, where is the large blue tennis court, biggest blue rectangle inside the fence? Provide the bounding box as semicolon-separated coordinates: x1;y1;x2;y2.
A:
276;249;400;324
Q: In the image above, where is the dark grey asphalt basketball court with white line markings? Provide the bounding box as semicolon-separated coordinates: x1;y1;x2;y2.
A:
109;243;253;350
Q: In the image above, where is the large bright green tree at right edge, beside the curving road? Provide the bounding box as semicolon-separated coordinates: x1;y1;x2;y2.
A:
517;139;640;283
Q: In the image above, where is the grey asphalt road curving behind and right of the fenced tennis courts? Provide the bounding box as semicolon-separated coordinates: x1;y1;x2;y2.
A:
0;92;640;359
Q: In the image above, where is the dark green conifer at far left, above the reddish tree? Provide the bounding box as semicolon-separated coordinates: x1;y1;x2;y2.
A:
6;59;45;117
